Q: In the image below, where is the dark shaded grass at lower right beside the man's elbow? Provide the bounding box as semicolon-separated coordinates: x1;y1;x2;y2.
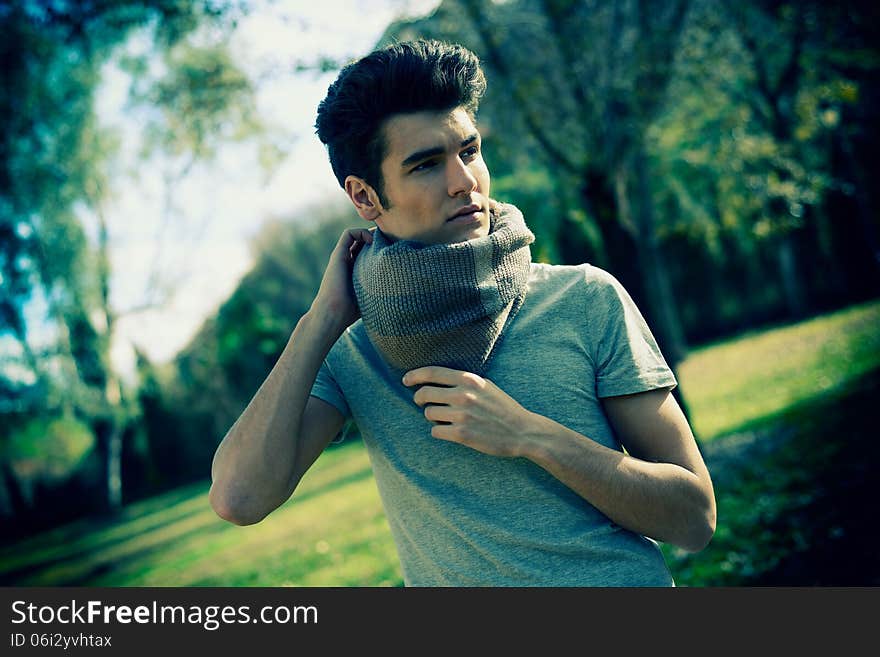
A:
662;368;880;586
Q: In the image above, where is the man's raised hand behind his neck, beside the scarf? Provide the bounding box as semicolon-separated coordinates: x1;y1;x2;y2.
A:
312;228;373;329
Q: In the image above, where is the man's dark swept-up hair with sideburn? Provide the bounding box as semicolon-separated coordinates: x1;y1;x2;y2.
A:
315;40;486;205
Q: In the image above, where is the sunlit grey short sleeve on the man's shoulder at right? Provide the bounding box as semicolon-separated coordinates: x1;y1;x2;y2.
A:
589;270;677;397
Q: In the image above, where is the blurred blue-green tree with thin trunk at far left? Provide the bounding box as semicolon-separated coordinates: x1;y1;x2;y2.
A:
0;0;258;510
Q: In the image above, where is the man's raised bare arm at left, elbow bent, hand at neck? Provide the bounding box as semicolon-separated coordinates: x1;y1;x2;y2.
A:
209;229;372;525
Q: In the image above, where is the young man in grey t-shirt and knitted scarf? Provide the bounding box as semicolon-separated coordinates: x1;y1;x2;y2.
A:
211;41;715;586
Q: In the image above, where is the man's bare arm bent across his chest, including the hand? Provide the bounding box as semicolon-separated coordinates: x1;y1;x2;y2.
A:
404;367;715;551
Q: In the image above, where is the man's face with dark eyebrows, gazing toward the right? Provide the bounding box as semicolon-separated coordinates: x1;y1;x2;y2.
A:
375;108;489;244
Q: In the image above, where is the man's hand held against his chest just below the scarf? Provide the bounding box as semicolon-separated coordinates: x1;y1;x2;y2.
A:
403;367;534;457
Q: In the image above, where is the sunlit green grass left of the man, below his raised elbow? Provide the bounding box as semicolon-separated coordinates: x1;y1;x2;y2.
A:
0;442;402;586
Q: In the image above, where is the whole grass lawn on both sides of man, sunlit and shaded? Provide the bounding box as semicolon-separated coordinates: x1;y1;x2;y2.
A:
0;302;880;586
